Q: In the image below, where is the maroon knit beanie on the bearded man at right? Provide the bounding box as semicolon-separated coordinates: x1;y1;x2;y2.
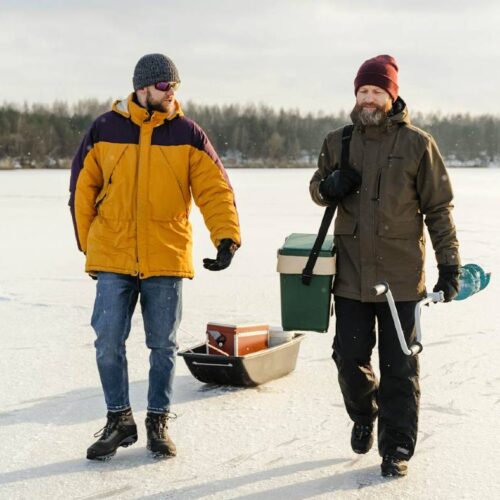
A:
354;55;399;101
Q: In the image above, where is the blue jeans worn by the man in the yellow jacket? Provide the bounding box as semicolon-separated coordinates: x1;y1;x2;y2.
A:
91;272;182;413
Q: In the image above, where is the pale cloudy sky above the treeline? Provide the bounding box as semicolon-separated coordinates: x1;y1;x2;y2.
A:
0;0;500;114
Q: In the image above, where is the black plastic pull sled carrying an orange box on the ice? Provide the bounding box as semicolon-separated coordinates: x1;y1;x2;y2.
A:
178;334;304;387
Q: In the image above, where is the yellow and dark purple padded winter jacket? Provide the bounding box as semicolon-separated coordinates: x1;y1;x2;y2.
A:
69;94;241;278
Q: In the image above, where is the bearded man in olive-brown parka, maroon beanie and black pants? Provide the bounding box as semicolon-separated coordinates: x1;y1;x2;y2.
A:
310;55;460;476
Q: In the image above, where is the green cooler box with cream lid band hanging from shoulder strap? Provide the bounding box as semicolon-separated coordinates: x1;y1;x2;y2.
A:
278;233;335;332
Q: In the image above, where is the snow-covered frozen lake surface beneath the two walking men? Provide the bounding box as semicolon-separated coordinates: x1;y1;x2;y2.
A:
0;169;500;499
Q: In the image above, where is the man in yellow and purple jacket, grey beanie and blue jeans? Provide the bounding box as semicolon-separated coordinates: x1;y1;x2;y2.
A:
70;54;240;460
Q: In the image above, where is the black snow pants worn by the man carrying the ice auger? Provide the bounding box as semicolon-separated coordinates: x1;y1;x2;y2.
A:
332;296;420;459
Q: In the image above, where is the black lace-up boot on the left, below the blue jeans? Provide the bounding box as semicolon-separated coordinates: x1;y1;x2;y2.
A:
87;409;137;461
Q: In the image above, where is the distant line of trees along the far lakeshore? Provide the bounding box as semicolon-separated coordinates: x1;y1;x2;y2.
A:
0;99;500;168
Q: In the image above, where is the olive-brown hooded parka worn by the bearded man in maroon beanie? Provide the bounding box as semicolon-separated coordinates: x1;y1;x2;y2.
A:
310;98;460;302
